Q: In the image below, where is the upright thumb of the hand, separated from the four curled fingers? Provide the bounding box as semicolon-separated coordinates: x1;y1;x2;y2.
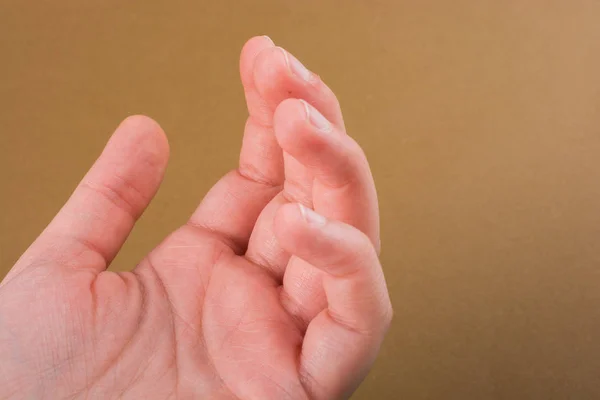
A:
5;116;169;282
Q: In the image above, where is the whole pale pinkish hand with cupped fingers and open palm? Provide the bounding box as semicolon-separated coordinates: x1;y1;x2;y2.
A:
0;36;392;400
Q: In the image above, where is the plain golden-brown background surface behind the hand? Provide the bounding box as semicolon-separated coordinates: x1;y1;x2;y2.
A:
0;0;600;399
